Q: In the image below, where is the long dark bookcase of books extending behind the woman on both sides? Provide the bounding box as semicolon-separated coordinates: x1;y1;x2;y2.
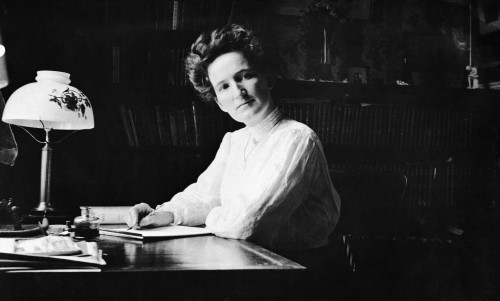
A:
106;81;498;223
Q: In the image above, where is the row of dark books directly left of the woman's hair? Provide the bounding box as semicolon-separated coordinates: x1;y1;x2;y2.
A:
111;45;188;86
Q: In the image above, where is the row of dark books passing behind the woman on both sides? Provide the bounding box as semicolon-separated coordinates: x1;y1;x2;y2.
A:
120;102;477;149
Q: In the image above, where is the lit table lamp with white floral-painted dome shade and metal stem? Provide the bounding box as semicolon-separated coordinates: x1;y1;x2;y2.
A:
2;71;94;216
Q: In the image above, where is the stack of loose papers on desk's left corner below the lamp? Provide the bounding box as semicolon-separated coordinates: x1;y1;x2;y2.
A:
0;236;106;273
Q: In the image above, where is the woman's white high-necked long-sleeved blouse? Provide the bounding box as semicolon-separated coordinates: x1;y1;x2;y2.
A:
157;109;340;250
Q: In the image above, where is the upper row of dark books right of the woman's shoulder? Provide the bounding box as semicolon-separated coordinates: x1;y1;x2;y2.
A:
283;101;475;148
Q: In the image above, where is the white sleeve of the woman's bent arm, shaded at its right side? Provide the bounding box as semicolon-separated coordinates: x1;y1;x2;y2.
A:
206;128;338;247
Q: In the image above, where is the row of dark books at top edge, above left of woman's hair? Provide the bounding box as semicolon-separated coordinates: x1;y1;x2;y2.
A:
105;0;232;33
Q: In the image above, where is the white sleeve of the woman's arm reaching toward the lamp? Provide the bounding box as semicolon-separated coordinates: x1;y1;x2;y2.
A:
156;133;231;226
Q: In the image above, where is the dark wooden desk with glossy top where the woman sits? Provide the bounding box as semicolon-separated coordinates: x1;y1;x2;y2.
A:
0;235;305;301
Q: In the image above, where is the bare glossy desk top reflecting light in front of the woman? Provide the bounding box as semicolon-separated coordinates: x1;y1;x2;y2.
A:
97;235;305;272
